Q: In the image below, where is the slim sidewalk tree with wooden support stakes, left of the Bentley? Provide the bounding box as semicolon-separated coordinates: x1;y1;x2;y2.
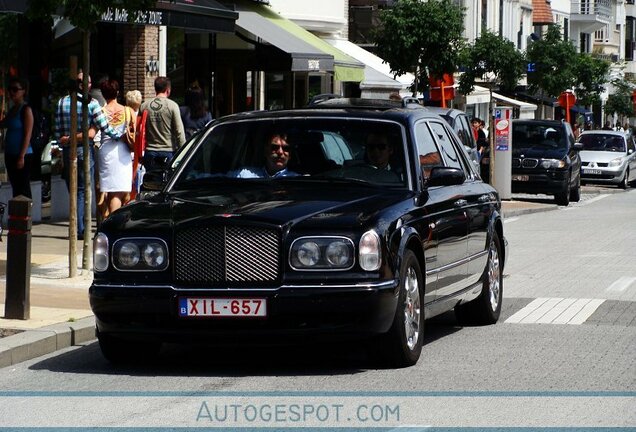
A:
27;0;155;277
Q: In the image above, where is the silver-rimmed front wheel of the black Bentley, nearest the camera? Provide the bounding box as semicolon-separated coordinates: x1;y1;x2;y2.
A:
379;250;424;367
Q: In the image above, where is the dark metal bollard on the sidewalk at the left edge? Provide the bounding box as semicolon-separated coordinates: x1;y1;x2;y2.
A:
4;195;33;320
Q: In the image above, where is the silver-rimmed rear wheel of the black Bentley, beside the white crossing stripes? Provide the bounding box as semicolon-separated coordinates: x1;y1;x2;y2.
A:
455;232;503;325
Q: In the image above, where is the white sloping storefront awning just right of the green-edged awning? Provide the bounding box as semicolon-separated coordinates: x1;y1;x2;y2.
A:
324;39;415;91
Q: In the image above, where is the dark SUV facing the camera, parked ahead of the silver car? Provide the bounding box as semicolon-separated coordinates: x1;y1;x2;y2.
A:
511;120;582;206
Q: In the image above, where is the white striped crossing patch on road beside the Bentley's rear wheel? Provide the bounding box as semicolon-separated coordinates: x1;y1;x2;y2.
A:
506;297;605;325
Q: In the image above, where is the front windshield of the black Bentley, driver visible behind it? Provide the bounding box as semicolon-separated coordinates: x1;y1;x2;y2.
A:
172;118;406;190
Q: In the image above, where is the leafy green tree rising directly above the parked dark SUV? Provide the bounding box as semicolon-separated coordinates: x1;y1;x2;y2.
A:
526;24;578;97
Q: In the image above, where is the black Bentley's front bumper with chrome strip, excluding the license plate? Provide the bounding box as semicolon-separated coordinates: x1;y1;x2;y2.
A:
89;281;397;342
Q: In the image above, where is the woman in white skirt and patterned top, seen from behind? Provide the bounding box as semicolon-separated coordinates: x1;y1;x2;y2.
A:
98;80;134;218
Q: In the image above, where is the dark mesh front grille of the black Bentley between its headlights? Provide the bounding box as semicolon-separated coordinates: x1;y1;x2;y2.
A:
175;226;281;284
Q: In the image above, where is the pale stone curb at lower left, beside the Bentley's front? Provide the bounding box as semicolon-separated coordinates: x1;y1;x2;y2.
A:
0;317;95;368
